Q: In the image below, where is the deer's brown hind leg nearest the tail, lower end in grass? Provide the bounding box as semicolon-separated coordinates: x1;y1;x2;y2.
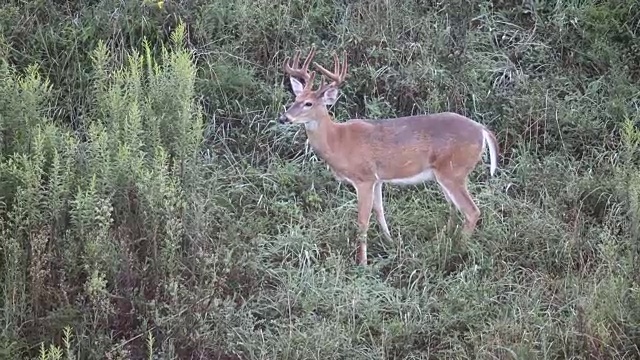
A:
436;174;480;234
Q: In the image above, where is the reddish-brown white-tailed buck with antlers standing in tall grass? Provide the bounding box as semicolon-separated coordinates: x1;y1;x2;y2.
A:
279;46;498;265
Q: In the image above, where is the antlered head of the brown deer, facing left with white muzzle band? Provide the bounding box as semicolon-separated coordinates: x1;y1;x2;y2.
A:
278;46;347;124
